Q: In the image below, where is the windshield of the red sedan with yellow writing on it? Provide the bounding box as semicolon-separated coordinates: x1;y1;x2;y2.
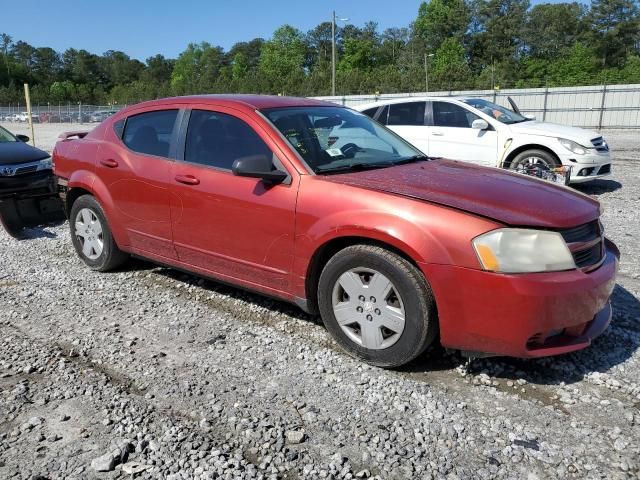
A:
262;107;426;173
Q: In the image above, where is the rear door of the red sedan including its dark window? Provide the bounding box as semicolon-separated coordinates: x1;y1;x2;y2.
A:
96;107;180;258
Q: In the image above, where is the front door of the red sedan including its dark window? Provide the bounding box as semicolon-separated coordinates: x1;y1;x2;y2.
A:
171;107;298;293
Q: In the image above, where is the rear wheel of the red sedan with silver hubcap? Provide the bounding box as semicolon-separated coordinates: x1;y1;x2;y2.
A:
69;195;129;272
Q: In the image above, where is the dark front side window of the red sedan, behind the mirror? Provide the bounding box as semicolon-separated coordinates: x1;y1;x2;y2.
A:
184;110;273;170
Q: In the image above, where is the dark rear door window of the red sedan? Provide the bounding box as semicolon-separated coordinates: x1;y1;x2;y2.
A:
122;110;178;158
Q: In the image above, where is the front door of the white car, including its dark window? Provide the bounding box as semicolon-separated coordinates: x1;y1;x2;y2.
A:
428;101;498;167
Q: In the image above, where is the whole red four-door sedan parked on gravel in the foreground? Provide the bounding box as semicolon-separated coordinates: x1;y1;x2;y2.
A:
53;95;619;367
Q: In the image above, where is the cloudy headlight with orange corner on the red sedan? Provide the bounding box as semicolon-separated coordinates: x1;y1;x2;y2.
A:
472;228;576;273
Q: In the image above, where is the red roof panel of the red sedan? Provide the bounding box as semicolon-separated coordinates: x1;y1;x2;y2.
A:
123;94;340;110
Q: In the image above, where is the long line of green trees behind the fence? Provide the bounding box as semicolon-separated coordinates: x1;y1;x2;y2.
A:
0;0;640;105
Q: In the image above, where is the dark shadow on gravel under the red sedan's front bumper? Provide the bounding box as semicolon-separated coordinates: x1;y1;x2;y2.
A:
468;285;640;385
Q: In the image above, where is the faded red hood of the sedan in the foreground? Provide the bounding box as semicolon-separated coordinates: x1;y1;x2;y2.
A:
323;159;600;228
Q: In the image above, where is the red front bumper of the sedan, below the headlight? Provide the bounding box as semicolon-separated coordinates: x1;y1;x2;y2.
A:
421;240;620;358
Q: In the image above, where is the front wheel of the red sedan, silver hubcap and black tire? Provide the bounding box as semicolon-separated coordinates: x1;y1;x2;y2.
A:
318;245;438;368
